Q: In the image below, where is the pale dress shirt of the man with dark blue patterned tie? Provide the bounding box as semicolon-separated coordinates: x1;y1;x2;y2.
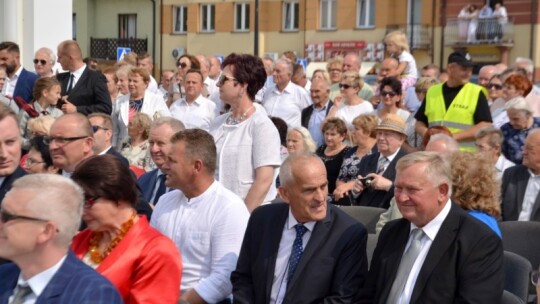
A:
270;208;316;304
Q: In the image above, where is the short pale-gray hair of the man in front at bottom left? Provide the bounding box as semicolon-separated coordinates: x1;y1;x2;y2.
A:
10;174;84;248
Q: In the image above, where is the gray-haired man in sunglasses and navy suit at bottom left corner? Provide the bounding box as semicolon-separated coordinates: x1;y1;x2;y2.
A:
0;174;122;304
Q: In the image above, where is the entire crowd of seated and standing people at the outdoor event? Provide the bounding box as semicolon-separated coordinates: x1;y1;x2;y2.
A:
0;27;540;304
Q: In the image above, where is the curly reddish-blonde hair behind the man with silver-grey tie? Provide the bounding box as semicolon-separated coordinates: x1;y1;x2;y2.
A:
450;151;501;217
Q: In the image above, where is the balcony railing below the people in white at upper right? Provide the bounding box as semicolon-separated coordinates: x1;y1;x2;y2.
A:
444;18;514;47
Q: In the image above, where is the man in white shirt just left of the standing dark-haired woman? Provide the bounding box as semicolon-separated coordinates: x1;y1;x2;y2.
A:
170;70;217;131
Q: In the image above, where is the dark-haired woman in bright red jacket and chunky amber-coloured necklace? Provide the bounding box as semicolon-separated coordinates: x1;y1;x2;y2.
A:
71;154;182;303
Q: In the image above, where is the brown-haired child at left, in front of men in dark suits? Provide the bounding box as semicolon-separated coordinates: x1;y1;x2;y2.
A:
19;77;64;150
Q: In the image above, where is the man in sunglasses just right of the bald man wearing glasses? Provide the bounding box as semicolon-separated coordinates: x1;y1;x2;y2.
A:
88;113;129;167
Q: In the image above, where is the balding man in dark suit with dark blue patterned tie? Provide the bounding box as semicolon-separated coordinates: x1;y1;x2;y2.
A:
231;154;367;304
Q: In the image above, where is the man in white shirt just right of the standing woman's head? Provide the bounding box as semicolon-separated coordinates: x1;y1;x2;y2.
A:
262;59;311;127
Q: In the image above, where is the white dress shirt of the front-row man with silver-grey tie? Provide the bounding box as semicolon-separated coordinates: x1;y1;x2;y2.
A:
398;200;452;304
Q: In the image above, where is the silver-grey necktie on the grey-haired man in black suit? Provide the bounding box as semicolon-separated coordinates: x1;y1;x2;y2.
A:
386;228;424;303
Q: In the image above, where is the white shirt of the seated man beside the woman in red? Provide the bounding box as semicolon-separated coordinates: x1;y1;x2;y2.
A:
150;181;249;303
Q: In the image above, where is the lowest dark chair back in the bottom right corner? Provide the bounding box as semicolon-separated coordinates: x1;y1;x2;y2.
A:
504;251;532;302
